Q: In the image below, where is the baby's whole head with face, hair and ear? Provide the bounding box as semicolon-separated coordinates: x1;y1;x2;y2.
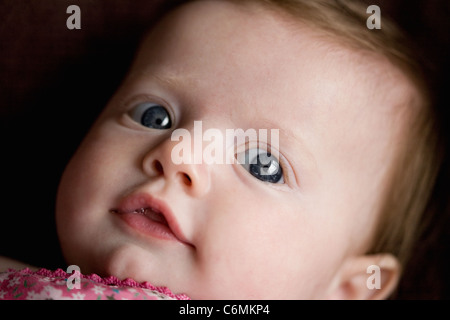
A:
56;0;442;299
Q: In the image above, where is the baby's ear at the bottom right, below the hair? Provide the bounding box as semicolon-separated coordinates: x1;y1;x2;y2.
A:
328;254;400;300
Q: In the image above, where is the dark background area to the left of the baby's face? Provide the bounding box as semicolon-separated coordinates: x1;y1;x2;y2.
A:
0;0;167;270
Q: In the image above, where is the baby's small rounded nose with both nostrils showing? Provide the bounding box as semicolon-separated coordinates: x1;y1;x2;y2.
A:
142;139;211;197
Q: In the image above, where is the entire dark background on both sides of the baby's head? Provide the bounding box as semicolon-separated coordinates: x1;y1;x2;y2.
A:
0;0;450;299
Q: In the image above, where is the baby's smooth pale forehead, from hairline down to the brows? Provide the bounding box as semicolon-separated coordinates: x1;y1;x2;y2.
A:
125;0;414;162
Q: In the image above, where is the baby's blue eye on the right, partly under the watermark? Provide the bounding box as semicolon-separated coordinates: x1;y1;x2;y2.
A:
237;149;284;183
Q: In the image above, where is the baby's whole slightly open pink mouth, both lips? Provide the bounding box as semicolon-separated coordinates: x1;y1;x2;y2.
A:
110;194;192;246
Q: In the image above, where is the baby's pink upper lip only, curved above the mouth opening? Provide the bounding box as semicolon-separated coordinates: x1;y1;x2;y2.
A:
110;192;192;246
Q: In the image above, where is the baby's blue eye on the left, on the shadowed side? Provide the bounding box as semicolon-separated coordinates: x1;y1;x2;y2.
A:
130;102;172;130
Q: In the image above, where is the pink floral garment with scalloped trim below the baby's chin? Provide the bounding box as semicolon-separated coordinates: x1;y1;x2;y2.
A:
0;268;189;300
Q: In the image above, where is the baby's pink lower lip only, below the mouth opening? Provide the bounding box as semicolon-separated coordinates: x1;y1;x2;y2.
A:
118;213;180;242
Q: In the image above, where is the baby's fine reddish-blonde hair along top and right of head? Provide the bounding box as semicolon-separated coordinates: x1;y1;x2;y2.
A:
158;0;442;288
